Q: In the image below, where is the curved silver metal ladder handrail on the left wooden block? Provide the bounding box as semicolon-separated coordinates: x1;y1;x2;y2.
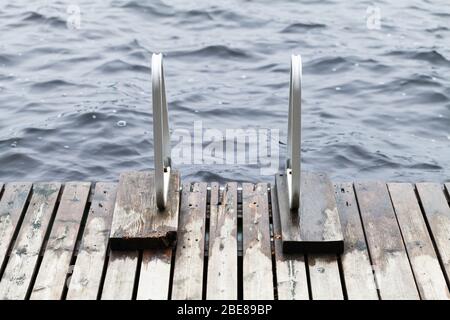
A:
152;53;171;210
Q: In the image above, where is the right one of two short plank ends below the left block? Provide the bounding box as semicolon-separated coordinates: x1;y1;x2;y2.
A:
137;248;172;300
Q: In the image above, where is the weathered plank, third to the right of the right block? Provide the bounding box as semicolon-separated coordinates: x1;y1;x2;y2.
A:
388;183;450;300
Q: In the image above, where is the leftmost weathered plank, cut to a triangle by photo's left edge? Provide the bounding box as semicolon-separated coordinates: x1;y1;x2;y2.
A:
0;182;31;270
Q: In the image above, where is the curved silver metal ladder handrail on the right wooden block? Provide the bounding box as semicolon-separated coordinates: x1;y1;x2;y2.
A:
286;55;302;210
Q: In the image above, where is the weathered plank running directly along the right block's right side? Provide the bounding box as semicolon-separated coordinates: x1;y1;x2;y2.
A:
335;183;378;300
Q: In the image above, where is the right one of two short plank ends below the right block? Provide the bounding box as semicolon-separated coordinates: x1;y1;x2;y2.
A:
308;254;344;300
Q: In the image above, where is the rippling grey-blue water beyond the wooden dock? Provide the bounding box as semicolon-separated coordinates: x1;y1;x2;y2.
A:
0;0;450;181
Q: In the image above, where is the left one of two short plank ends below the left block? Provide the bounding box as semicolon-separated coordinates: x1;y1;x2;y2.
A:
101;251;139;300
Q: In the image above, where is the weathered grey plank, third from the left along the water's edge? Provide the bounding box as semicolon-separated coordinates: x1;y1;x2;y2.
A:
30;182;91;300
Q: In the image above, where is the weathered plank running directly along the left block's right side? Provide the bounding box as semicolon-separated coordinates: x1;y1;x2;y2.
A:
172;183;207;300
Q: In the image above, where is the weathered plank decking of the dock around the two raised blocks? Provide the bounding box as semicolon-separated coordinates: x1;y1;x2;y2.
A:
0;182;450;300
